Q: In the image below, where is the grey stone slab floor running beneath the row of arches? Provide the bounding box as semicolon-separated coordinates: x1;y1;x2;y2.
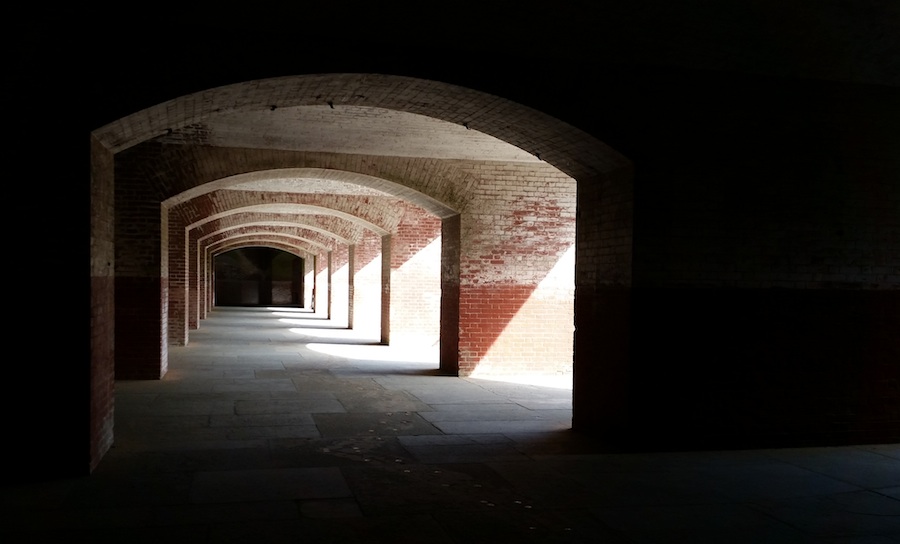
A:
0;308;900;544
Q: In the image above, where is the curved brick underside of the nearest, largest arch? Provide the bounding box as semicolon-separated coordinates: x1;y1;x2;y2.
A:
92;74;630;180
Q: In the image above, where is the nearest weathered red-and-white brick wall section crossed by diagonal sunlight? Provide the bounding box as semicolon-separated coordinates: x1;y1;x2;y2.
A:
459;159;576;375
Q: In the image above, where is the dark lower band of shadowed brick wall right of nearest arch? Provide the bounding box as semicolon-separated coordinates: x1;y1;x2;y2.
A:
628;289;900;448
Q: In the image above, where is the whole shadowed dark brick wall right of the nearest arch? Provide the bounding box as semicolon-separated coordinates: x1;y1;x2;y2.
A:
575;71;900;449
